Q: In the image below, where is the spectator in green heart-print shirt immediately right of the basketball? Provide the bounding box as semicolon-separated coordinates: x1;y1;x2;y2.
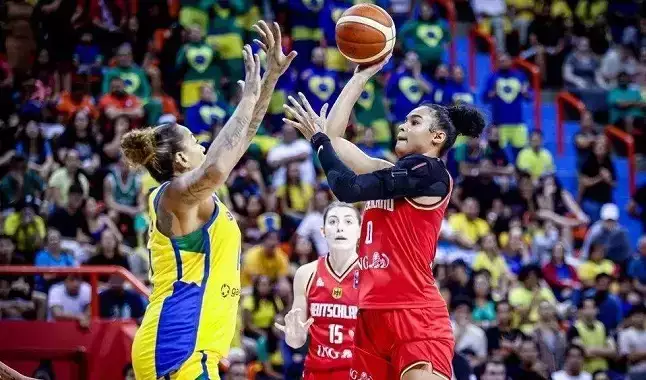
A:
399;3;451;72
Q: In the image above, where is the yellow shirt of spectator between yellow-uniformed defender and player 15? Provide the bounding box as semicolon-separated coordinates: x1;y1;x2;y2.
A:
241;245;289;287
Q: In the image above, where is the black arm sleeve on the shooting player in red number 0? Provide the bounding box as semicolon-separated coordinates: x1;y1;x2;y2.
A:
312;133;450;202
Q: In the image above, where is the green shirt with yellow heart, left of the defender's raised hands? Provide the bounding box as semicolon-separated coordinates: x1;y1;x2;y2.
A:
176;41;222;86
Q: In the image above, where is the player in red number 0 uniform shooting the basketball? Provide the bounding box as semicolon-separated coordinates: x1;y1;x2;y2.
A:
285;57;485;380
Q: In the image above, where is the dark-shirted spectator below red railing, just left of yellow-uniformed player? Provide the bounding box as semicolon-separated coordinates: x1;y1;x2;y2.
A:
99;274;146;320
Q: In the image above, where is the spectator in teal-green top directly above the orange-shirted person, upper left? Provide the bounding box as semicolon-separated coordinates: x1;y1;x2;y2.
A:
101;43;150;101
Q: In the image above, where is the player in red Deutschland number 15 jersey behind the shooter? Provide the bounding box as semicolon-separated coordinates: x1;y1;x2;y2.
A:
276;202;378;380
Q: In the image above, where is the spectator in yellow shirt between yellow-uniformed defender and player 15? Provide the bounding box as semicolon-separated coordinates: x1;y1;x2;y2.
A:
241;230;289;286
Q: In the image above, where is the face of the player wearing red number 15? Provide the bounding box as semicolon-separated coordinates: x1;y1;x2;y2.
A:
323;206;361;253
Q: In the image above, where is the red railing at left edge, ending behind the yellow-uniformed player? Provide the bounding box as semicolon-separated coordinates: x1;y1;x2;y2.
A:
0;265;150;318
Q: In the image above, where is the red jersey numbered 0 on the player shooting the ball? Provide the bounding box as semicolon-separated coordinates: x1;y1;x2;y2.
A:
359;177;452;309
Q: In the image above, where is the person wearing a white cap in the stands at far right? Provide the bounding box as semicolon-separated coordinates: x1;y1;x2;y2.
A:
581;203;631;270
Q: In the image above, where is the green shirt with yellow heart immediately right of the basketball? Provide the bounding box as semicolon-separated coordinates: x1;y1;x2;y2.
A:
397;20;451;63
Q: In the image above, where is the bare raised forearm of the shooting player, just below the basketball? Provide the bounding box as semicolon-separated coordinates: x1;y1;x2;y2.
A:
326;75;367;138
